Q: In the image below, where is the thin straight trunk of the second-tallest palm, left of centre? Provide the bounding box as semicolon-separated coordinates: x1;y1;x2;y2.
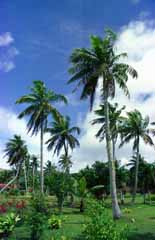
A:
40;123;44;193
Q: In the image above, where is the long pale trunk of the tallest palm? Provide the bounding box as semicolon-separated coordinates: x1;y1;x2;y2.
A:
104;92;121;219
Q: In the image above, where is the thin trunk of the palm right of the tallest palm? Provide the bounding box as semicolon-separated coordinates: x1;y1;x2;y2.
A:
132;137;139;203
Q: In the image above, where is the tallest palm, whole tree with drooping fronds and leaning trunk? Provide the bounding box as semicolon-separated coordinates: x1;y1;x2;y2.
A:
68;30;137;219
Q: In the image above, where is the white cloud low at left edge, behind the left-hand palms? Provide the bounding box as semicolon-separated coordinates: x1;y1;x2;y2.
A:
0;107;53;168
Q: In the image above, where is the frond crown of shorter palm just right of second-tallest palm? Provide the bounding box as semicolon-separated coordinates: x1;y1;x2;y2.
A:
46;114;80;161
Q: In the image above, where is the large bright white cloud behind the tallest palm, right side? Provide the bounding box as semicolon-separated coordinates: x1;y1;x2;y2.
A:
73;20;155;171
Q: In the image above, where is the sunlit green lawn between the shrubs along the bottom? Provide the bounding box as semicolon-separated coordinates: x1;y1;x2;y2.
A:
1;197;155;240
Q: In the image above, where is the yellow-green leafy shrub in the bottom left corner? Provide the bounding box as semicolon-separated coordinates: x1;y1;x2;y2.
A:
0;213;20;238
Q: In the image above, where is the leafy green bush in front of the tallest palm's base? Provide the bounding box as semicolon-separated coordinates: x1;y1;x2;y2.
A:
83;200;128;240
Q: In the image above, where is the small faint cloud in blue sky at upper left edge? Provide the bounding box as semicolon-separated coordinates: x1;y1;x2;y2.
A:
0;32;19;72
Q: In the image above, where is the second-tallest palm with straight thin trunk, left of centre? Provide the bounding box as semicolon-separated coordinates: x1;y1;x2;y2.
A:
16;81;67;193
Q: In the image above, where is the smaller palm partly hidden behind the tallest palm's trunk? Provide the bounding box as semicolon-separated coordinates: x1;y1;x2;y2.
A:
92;103;125;160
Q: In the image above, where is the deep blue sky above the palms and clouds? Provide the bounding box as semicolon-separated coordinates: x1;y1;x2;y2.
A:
0;0;155;170
